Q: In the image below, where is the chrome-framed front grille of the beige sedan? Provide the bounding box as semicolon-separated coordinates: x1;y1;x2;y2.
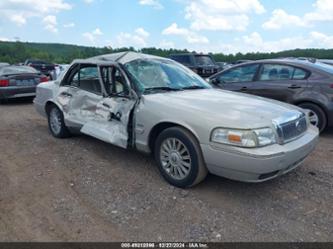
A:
278;115;308;143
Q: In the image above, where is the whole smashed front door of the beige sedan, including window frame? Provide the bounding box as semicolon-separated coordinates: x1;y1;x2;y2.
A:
81;64;136;148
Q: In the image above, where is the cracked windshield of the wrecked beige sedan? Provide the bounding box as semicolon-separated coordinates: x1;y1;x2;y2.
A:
125;59;211;93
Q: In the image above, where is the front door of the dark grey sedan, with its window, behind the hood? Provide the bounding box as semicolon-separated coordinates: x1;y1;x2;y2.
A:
213;64;259;93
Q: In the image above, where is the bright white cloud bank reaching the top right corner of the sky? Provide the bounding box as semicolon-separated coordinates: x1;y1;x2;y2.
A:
262;0;333;29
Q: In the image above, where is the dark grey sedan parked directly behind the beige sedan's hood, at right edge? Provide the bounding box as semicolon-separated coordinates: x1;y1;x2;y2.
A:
209;59;333;131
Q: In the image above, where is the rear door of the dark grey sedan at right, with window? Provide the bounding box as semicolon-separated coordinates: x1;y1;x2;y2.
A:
250;63;309;103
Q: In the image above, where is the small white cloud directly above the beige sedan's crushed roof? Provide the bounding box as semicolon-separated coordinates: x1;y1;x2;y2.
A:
116;28;150;48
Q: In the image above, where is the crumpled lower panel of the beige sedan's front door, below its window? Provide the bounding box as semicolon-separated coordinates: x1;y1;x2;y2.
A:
81;97;135;148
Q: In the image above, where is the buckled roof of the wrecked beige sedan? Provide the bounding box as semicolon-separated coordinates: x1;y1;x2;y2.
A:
73;51;169;65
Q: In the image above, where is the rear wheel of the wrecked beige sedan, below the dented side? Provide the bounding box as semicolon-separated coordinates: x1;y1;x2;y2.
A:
47;105;71;138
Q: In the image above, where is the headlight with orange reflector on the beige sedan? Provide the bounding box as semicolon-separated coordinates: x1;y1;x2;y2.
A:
211;128;276;148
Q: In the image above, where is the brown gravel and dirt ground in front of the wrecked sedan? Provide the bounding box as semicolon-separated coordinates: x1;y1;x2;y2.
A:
0;98;333;241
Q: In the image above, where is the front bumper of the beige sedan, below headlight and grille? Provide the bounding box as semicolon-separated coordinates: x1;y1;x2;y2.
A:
201;126;319;182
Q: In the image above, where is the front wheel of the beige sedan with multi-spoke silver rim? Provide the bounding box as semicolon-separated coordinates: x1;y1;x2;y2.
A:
154;127;208;188
